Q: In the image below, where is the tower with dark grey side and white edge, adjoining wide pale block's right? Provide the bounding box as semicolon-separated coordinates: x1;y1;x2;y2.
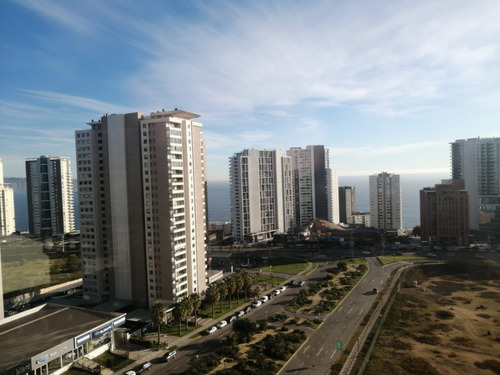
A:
287;145;339;226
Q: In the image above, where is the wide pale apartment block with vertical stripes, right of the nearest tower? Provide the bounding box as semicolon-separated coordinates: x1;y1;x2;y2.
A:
229;149;295;242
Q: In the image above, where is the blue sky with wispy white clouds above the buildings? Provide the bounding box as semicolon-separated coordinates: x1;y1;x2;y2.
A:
0;0;500;183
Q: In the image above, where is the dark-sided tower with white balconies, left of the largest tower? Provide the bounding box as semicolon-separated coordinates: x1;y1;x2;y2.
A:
26;155;75;238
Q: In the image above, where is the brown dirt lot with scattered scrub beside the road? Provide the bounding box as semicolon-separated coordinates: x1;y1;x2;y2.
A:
365;264;500;375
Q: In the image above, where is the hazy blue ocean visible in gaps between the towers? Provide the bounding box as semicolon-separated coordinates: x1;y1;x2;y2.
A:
14;174;449;231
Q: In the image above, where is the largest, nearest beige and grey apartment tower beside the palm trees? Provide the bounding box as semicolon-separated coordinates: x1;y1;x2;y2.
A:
75;109;206;307
